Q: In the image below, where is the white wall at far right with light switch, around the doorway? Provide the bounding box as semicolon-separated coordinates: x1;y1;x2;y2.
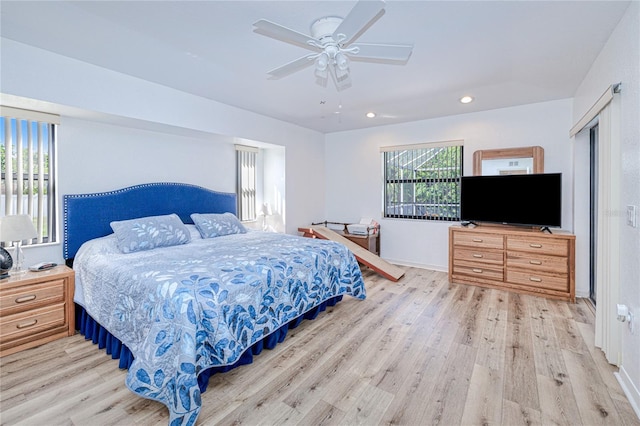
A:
573;1;640;416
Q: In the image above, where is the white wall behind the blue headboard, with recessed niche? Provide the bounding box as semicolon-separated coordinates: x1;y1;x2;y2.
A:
0;38;325;263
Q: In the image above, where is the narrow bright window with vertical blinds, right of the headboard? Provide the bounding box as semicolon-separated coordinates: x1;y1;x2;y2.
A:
236;145;258;221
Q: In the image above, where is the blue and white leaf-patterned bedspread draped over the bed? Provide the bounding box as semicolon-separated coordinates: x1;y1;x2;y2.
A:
74;225;366;425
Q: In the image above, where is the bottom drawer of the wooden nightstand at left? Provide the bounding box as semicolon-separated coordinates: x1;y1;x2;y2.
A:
0;302;65;344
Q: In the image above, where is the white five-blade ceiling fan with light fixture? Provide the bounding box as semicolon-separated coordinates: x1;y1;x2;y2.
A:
253;0;413;90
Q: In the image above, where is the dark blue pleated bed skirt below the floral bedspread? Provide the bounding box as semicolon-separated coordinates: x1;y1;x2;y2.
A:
76;296;342;392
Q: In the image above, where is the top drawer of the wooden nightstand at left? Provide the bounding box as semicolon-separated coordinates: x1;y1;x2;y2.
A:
0;279;65;316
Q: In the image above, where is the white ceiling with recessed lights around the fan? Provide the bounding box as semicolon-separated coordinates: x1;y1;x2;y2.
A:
0;0;629;133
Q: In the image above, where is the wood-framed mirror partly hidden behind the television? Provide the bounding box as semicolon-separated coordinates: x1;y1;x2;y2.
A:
473;146;544;176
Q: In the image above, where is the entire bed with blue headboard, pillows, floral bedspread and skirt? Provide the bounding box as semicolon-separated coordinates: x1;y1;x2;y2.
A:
63;183;366;425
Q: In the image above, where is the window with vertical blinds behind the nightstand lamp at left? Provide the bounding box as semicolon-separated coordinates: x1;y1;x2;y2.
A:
0;106;59;245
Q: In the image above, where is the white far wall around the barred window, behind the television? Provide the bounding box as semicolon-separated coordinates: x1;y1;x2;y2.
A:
324;99;573;271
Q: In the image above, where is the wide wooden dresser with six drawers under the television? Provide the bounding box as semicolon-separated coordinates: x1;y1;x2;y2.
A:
449;225;575;302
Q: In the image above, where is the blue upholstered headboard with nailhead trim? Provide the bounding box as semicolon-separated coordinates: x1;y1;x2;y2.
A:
63;182;236;261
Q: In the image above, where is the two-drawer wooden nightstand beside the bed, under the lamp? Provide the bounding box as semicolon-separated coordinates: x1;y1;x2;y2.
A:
0;265;75;356
